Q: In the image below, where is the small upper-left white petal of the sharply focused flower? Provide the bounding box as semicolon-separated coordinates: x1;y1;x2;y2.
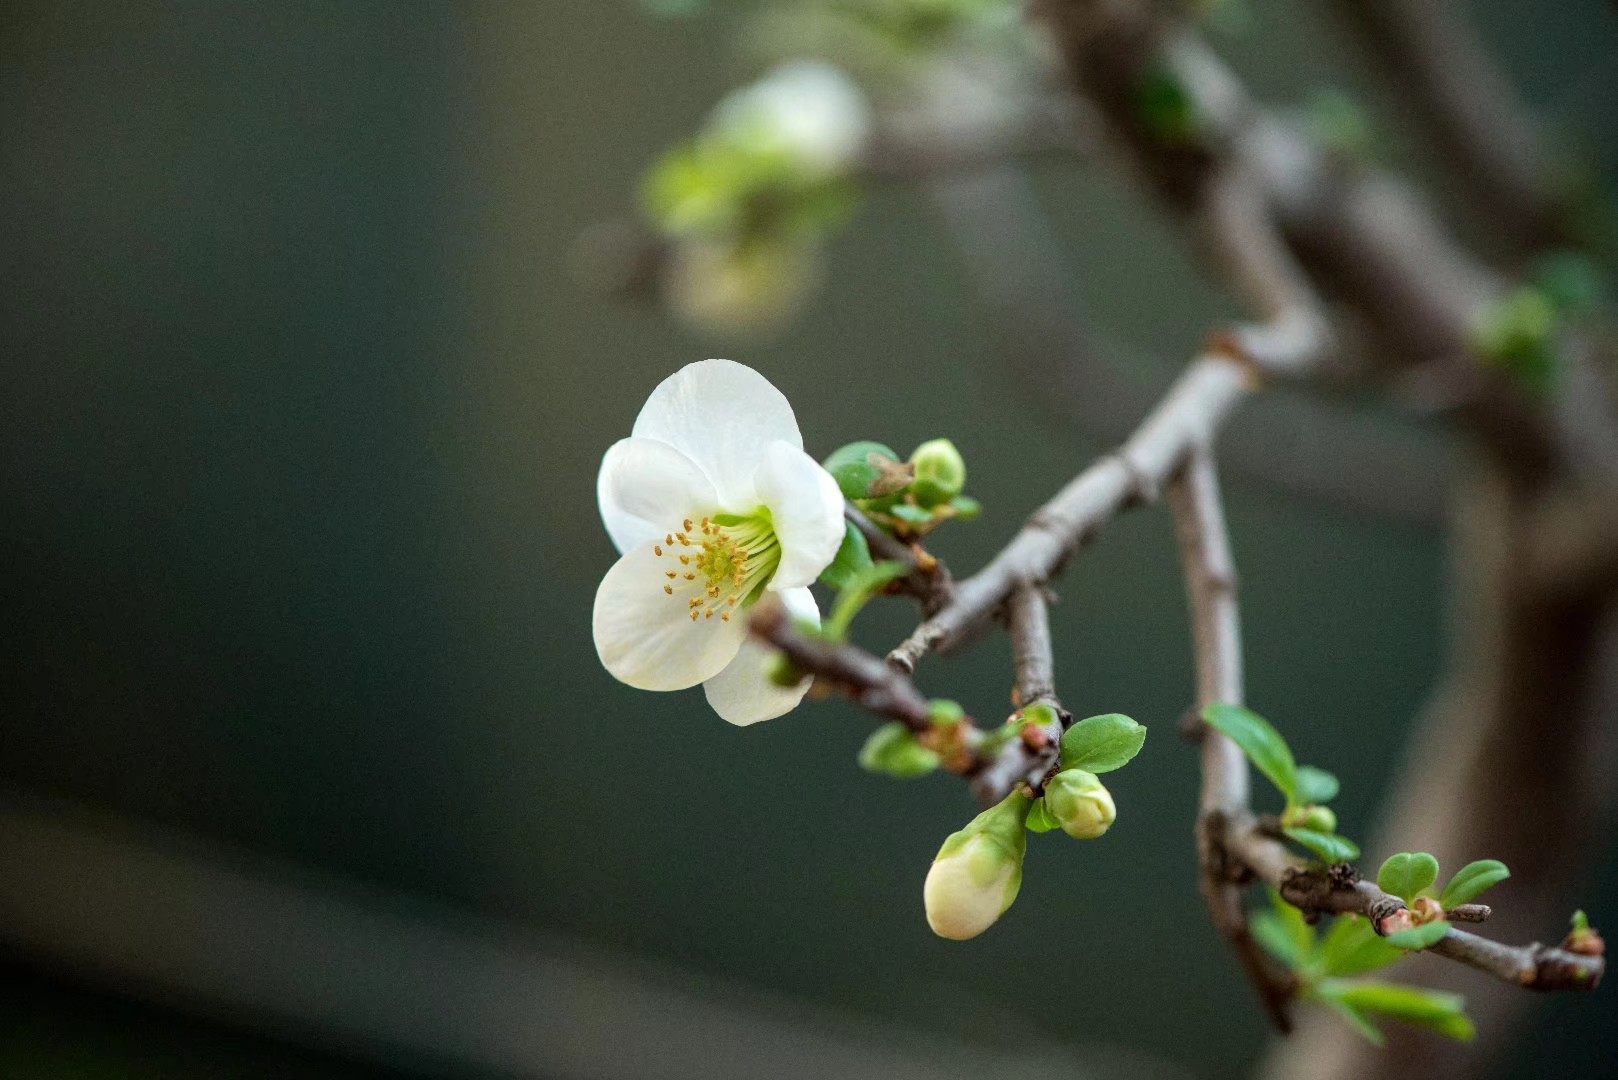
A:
595;439;718;552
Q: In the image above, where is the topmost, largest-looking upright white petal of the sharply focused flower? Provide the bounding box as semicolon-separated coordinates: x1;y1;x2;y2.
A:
631;359;804;513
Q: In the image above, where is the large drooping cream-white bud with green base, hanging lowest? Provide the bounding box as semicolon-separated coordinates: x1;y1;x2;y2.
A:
922;792;1034;941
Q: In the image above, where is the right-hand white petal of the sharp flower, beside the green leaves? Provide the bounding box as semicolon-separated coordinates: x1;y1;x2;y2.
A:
752;442;843;591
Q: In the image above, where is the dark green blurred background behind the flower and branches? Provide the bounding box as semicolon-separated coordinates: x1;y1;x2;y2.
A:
0;0;1618;1077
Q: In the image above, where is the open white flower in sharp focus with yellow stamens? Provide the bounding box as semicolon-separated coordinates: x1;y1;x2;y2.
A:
594;359;843;724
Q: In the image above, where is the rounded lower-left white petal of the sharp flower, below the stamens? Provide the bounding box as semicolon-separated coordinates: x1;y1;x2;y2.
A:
592;541;748;690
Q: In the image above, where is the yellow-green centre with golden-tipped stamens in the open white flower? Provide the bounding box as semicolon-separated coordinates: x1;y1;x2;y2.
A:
652;507;781;622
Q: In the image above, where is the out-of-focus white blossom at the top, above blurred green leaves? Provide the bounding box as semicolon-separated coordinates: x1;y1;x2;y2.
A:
714;60;870;176
